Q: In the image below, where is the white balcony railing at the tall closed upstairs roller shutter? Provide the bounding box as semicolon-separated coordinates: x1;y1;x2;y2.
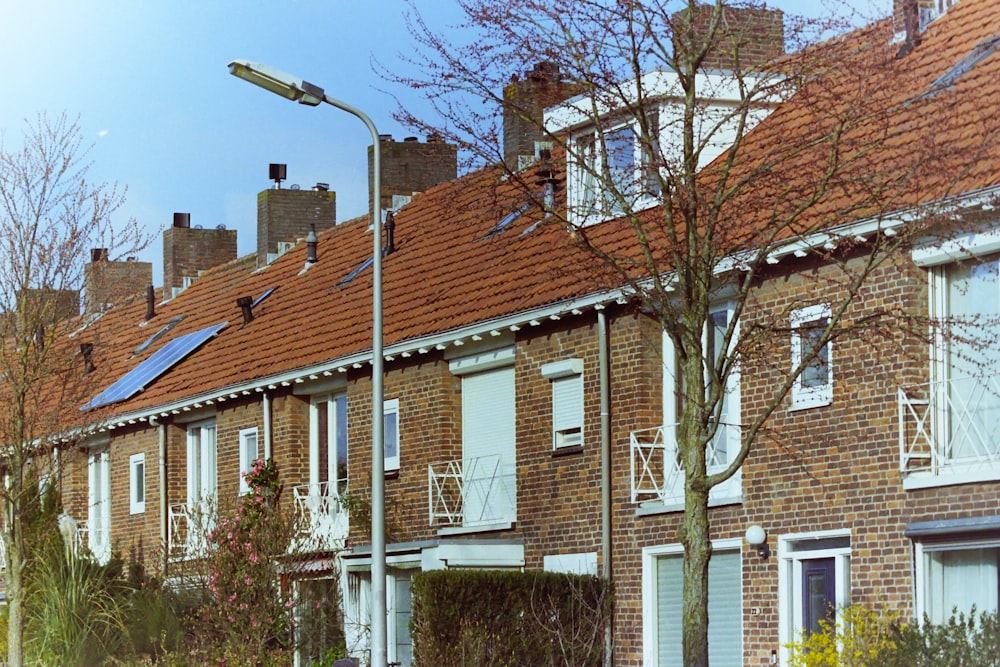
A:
427;454;517;527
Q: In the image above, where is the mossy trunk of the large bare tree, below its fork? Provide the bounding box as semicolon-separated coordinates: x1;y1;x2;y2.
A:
680;473;712;667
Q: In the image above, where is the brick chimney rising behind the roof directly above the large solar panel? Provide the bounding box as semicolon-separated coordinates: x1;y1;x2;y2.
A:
163;213;236;299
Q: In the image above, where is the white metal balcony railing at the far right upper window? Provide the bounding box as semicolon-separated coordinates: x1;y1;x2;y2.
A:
897;376;1000;475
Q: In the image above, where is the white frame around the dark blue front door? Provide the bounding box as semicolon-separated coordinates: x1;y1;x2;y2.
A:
778;529;852;665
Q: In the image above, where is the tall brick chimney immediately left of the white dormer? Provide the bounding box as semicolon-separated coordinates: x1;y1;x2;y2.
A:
503;62;580;169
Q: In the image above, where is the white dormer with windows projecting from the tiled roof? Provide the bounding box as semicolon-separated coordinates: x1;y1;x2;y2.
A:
545;70;778;225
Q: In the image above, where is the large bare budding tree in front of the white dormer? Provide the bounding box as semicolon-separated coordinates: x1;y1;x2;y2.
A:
384;0;998;667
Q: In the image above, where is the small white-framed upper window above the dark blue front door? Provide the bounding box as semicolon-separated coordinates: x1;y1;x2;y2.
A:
791;304;833;410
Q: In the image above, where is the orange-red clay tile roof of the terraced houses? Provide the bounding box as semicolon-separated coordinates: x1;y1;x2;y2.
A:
73;0;1000;428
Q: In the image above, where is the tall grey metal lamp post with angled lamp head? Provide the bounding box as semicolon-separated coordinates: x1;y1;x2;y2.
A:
229;60;388;667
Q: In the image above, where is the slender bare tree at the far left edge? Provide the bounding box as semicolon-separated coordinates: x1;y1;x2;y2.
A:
0;114;145;666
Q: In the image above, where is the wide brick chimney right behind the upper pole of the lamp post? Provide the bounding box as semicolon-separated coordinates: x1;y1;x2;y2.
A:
368;134;458;217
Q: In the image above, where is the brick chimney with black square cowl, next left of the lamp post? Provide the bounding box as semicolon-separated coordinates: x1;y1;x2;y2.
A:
257;183;337;267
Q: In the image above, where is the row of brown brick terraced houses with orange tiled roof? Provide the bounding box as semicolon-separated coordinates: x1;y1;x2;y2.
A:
1;0;1000;666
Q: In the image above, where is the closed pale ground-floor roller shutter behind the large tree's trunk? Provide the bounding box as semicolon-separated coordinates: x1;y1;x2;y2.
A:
656;551;743;667
